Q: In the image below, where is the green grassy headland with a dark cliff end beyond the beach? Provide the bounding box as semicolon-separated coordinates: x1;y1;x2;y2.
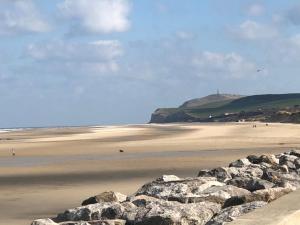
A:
150;94;300;123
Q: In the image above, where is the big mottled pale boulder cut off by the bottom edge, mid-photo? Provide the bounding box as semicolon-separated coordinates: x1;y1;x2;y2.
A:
134;200;221;225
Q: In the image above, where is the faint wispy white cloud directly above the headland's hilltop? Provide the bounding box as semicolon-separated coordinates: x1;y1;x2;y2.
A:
192;51;257;78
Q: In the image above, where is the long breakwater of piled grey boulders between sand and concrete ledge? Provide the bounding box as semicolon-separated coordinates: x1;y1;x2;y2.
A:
32;150;300;225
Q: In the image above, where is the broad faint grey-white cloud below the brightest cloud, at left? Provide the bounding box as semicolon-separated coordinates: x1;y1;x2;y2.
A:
26;40;123;74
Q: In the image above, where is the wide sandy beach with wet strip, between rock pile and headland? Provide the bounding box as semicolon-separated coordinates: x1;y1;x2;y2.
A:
0;123;300;225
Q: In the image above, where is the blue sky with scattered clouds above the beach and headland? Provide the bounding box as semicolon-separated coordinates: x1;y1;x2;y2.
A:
0;0;300;128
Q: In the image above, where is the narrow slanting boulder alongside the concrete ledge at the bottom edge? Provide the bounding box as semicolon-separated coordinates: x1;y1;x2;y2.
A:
206;202;267;225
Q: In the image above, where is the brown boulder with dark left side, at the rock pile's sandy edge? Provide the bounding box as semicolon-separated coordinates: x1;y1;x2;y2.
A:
81;191;127;206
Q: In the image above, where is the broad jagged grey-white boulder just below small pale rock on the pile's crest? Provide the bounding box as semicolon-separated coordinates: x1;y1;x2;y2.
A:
135;177;225;203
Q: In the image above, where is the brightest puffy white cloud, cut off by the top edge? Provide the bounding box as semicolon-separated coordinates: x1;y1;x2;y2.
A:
58;0;130;33
